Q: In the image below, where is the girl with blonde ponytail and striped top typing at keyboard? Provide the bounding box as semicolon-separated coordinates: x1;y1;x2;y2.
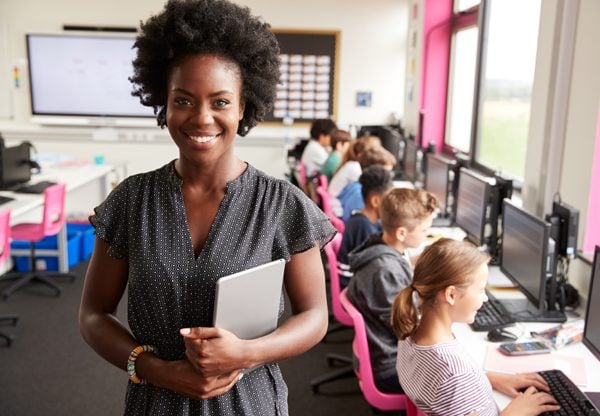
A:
391;239;559;416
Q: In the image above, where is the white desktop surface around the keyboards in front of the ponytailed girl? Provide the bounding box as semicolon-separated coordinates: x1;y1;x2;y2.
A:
453;282;600;409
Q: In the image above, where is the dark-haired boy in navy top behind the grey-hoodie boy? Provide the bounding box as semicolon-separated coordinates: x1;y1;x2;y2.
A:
338;165;394;288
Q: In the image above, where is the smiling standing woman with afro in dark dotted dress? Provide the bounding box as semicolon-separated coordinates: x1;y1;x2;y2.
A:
79;0;334;416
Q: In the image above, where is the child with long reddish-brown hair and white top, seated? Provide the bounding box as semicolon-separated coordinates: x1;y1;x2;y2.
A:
327;136;381;200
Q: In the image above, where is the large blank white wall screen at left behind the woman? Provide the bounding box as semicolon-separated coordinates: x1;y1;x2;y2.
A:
27;34;154;117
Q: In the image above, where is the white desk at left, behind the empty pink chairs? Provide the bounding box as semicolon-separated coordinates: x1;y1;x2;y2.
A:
0;164;125;272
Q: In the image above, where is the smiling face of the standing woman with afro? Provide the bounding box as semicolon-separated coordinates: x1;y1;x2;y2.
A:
167;55;244;167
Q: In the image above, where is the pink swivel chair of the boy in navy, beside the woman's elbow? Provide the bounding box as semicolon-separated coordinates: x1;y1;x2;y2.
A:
310;243;354;393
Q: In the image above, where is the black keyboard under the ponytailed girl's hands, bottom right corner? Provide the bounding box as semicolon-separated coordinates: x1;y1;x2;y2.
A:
540;370;600;416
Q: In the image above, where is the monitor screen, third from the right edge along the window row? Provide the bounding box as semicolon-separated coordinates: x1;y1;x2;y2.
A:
455;168;490;246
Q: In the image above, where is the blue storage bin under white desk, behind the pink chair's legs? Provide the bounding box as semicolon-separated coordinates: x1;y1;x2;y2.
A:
10;227;82;272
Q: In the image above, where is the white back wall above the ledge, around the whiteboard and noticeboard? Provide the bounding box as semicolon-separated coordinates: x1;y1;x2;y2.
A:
0;0;408;129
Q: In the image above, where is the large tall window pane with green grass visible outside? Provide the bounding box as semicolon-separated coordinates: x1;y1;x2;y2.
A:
474;0;541;179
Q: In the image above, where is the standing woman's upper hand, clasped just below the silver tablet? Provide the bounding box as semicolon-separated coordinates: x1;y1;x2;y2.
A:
180;327;248;378
